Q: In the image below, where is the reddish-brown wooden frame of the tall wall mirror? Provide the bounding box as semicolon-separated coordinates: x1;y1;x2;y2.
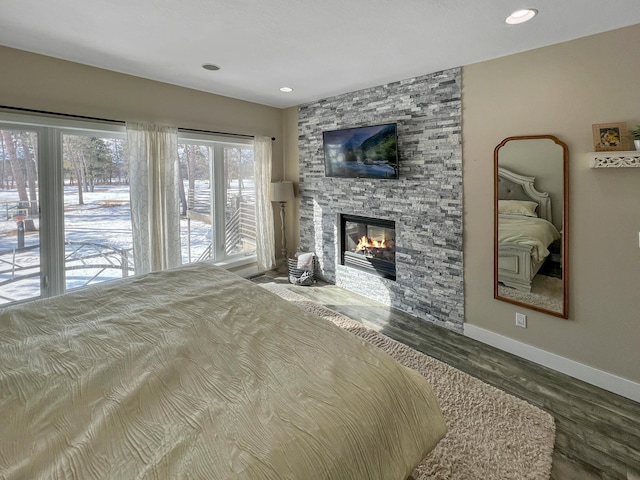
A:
493;135;569;319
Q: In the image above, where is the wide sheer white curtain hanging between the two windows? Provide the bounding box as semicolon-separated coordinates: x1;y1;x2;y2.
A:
127;122;182;275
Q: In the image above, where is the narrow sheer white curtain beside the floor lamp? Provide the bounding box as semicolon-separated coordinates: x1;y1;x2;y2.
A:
254;137;276;270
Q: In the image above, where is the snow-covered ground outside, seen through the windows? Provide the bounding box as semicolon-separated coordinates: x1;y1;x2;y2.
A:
0;185;216;303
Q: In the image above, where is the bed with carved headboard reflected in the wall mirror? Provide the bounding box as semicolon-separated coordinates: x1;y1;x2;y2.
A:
497;168;560;293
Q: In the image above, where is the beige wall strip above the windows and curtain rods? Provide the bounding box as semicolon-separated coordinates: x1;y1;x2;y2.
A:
0;46;282;142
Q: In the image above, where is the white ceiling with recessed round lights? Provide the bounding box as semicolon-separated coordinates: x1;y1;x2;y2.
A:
0;0;640;108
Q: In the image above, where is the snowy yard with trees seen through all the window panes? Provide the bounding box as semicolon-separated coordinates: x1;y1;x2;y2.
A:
0;130;255;304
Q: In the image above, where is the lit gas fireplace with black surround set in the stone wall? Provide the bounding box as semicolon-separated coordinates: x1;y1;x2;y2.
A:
339;215;396;280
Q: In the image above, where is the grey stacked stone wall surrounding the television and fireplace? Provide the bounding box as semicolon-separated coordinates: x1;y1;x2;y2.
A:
298;68;464;331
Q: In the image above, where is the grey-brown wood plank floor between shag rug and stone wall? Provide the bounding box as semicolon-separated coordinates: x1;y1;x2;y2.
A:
252;271;640;480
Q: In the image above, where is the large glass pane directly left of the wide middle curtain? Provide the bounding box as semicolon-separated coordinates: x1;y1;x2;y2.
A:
62;134;133;290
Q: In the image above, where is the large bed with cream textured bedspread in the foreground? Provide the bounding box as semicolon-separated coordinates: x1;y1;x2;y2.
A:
0;262;446;480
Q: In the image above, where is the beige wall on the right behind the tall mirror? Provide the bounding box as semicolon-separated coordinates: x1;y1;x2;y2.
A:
462;25;640;382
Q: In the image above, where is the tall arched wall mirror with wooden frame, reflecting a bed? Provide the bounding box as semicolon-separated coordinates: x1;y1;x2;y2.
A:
494;135;569;318
